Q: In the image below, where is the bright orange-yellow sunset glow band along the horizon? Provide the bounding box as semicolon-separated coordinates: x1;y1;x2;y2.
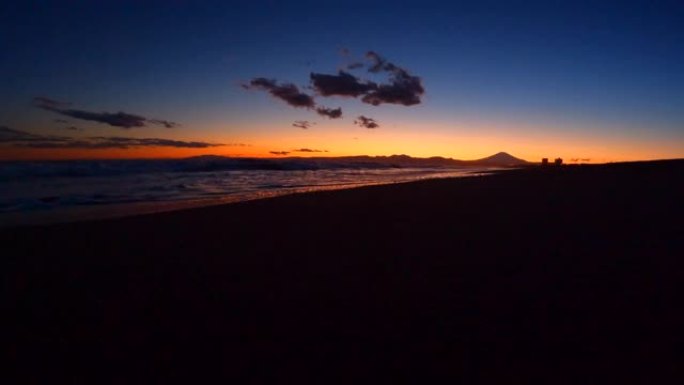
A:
0;122;684;163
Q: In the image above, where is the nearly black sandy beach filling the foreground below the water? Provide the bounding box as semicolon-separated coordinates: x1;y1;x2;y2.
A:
5;161;684;384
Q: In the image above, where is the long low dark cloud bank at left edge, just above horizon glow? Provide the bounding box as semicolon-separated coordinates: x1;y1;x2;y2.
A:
0;127;224;149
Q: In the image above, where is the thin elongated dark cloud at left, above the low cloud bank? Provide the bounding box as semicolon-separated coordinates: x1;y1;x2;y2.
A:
33;97;178;128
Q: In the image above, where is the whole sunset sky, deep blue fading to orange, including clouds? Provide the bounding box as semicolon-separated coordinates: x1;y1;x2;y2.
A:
0;0;684;162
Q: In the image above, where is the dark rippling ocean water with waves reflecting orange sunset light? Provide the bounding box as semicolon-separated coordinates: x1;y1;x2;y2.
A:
0;156;494;226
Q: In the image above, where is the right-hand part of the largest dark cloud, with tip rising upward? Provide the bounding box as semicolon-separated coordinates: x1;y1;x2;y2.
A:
361;51;425;106
